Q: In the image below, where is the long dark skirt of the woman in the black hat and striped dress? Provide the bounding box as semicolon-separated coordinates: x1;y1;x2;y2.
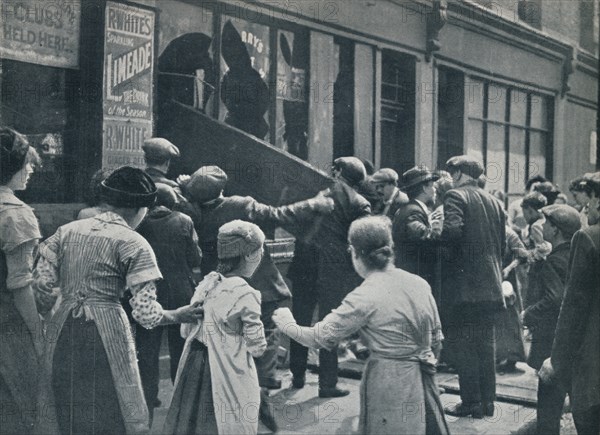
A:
52;315;126;434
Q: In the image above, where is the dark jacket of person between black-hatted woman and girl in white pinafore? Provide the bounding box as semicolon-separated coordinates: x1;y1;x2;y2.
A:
137;206;202;310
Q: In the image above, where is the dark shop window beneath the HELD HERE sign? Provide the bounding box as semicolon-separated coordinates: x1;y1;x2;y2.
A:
0;59;80;203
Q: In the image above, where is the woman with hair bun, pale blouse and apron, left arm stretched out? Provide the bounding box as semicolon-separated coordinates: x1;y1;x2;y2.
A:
273;217;449;435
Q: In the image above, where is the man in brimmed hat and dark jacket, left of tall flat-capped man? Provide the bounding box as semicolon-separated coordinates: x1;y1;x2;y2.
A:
392;166;441;288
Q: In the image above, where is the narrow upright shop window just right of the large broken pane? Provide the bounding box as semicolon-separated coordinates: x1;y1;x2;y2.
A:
274;30;310;160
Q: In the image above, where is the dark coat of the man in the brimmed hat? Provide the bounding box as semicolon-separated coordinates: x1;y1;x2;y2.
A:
392;199;437;286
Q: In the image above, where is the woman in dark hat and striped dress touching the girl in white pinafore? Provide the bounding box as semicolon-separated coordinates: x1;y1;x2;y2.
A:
36;167;202;434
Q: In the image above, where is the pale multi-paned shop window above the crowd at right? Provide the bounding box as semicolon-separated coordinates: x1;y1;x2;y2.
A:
464;79;552;194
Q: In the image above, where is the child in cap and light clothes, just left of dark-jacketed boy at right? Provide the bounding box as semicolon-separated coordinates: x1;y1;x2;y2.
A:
521;192;552;264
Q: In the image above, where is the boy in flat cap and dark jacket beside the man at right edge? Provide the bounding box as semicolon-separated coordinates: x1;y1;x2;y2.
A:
522;205;581;435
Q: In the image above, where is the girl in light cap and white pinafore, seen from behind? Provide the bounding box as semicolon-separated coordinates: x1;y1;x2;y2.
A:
163;220;267;434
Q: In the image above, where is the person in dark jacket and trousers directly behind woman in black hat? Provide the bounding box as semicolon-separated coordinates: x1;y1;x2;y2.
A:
135;183;202;413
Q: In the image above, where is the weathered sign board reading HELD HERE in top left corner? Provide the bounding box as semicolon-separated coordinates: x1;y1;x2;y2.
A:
0;0;81;68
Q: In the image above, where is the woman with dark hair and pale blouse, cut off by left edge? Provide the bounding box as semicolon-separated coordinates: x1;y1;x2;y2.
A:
0;127;43;434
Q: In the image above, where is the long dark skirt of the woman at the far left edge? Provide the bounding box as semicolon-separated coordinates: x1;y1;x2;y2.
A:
0;292;43;435
